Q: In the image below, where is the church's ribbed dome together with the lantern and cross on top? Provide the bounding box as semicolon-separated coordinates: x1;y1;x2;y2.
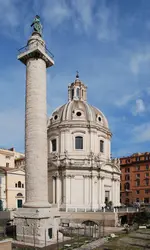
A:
50;73;109;129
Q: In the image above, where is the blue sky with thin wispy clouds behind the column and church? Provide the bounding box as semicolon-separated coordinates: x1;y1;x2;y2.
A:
0;0;150;157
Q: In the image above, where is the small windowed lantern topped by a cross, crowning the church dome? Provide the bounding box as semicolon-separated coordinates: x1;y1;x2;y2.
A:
68;71;87;101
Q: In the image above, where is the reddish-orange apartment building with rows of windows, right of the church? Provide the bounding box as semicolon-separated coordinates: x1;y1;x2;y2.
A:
120;152;150;205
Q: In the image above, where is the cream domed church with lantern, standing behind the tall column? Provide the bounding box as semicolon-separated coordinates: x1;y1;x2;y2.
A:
48;74;121;211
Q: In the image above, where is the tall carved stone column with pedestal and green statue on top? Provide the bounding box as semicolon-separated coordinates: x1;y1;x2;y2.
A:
15;16;59;245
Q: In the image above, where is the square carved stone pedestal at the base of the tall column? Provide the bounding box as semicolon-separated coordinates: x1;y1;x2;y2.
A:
14;208;60;246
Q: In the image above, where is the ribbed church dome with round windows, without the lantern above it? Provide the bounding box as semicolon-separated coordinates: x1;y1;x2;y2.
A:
50;100;109;128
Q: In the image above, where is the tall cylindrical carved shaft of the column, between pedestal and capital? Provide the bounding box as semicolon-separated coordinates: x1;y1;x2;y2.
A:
24;58;50;207
